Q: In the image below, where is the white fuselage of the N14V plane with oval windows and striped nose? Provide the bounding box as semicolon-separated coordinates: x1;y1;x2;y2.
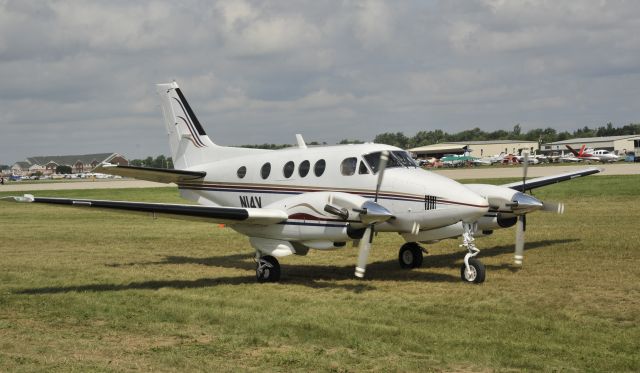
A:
179;144;488;238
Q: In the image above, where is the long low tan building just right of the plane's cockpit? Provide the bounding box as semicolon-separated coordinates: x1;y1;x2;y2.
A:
408;140;538;158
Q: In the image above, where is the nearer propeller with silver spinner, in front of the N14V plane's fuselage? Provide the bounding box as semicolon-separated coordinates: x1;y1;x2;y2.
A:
355;150;391;278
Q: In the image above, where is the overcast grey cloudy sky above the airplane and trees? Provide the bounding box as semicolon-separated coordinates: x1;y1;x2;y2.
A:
0;0;640;164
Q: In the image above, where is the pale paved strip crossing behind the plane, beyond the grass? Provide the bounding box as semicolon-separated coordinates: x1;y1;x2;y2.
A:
0;163;640;192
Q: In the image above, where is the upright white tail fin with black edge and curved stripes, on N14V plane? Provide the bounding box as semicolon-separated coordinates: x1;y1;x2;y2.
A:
157;82;216;169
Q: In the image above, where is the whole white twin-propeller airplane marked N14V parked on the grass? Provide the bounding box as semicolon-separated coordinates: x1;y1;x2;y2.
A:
5;82;599;283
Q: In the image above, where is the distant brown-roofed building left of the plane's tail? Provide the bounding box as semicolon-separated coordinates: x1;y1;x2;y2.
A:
11;153;129;176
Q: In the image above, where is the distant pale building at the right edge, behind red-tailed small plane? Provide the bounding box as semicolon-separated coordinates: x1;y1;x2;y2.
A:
540;135;640;155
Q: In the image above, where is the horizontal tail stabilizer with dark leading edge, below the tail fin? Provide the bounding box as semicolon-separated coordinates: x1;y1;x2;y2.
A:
92;163;207;184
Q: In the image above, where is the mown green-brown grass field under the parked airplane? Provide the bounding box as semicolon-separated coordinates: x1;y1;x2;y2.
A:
0;176;640;372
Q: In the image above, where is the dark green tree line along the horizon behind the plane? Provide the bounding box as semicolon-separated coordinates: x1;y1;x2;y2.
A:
129;123;640;169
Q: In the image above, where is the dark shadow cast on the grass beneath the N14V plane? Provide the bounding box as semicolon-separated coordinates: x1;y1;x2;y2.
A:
14;239;578;294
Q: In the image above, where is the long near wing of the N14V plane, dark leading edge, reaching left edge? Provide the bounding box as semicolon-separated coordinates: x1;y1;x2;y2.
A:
0;194;288;225
